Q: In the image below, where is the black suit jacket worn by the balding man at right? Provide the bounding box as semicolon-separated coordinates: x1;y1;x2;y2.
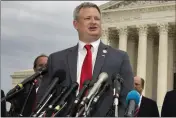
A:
137;96;159;117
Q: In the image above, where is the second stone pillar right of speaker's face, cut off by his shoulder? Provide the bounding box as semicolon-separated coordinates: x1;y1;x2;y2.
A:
118;26;128;51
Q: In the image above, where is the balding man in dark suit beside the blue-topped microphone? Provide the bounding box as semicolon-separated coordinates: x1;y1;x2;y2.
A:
134;76;159;117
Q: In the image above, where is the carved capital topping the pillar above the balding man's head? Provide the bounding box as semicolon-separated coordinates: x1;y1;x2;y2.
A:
136;24;148;35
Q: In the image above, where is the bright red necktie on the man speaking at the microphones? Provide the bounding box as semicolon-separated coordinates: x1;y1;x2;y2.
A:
80;45;92;90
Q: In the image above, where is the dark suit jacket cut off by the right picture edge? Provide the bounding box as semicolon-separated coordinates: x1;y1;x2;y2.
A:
161;90;176;117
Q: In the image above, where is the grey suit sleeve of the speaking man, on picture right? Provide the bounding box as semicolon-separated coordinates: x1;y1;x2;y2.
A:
119;52;134;117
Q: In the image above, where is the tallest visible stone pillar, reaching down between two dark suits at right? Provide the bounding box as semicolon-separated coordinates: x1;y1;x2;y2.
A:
157;23;168;110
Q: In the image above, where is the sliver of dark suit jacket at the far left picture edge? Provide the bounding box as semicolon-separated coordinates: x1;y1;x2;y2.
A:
1;90;7;117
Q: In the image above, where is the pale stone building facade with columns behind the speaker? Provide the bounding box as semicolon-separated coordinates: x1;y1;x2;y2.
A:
100;0;176;112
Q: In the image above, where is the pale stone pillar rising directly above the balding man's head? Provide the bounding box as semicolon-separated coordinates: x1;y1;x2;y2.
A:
137;25;148;95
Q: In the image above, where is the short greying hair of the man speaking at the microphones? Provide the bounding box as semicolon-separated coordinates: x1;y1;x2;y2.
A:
73;2;101;20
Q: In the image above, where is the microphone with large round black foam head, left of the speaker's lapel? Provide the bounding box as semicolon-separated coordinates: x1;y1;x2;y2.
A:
32;70;66;115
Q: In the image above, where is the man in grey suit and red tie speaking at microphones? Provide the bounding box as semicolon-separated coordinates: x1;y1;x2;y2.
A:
43;2;133;117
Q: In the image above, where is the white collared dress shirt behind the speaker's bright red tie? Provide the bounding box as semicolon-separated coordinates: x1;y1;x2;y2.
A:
77;39;100;88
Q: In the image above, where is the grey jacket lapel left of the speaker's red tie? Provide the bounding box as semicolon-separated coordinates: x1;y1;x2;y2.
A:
67;45;78;82
